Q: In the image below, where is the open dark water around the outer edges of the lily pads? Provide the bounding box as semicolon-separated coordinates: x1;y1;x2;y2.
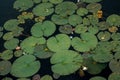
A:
0;0;120;80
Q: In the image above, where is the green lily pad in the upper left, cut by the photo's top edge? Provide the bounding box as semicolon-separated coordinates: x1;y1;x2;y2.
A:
13;0;34;12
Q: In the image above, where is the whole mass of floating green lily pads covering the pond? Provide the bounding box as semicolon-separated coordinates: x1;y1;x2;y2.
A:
0;0;120;80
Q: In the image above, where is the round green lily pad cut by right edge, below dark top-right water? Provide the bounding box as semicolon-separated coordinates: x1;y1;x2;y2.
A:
106;14;120;26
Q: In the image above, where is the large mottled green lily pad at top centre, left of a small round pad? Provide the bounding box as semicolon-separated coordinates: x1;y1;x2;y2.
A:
55;1;77;16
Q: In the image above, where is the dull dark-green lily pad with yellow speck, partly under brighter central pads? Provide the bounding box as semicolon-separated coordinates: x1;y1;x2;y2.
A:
34;44;53;59
